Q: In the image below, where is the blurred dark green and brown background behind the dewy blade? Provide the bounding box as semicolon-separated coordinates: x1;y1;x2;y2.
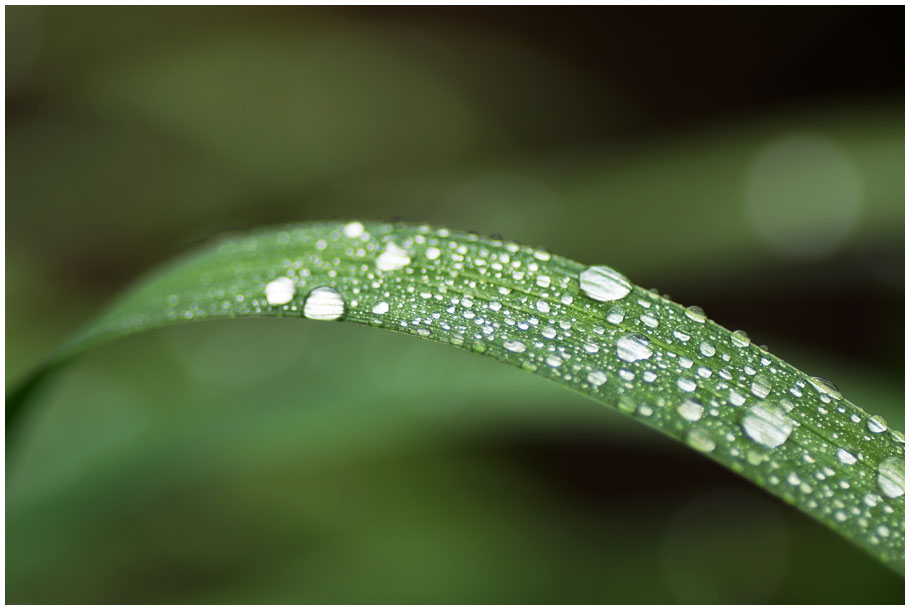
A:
5;7;904;603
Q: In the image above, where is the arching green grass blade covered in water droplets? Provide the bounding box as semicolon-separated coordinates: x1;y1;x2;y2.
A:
7;222;904;573
